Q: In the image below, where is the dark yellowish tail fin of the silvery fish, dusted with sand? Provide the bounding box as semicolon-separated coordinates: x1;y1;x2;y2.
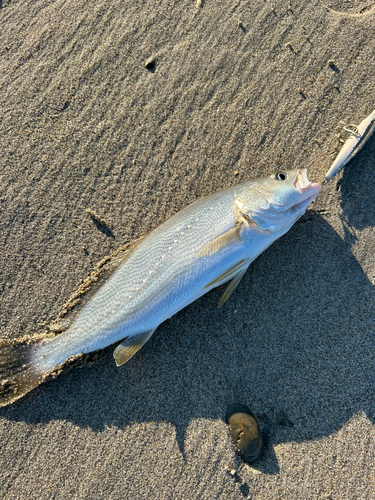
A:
0;340;46;407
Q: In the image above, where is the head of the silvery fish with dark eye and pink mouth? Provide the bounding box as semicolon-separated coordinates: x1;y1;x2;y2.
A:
235;169;322;233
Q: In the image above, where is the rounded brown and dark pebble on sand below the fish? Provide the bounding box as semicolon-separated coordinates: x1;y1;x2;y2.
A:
226;404;262;463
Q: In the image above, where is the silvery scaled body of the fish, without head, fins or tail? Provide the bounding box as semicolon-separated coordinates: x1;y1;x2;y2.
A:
35;186;244;368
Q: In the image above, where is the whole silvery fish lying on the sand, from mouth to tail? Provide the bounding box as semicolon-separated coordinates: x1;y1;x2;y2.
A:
0;169;321;406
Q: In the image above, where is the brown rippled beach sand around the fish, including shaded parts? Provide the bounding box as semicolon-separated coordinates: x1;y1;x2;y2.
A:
0;0;375;500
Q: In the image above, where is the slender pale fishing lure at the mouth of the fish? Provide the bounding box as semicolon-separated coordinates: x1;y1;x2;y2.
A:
323;110;375;184
